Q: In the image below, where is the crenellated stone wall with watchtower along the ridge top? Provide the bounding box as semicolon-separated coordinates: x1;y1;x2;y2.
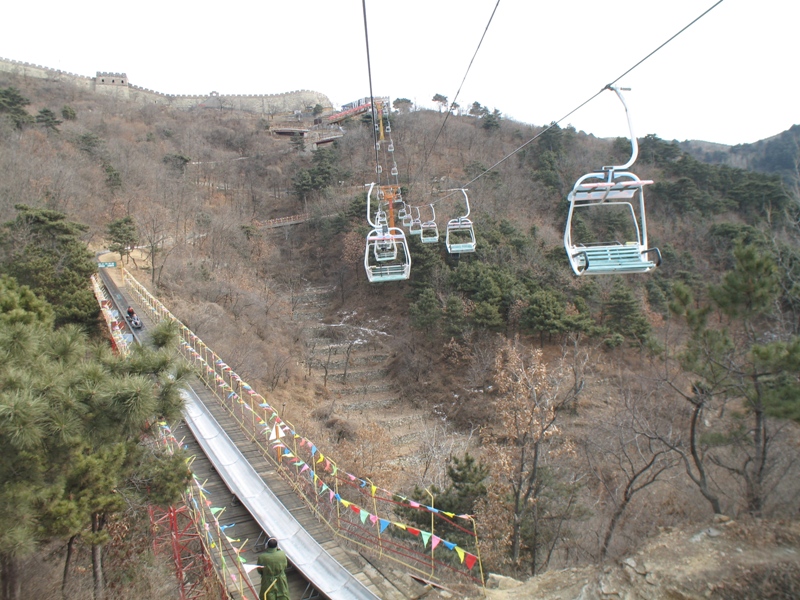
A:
0;58;333;115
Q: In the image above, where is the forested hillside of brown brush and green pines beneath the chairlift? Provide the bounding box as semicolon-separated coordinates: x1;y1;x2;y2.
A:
0;70;800;596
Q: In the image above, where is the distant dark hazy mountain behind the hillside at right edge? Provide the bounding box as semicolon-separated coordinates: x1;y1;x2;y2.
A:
678;125;800;179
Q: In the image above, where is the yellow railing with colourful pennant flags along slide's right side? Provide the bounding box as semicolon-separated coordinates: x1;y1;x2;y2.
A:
123;270;485;585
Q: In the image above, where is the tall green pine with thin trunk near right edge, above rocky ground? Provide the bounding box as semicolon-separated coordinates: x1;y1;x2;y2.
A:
671;246;800;516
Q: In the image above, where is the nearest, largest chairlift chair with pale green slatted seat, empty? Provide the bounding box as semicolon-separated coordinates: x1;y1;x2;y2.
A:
564;87;661;275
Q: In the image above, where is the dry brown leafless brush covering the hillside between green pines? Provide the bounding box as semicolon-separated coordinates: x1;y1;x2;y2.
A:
0;71;800;597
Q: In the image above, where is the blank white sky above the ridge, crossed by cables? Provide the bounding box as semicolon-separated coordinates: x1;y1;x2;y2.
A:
0;0;800;144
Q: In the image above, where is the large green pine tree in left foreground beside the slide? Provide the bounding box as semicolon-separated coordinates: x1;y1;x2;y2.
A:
0;314;188;600
